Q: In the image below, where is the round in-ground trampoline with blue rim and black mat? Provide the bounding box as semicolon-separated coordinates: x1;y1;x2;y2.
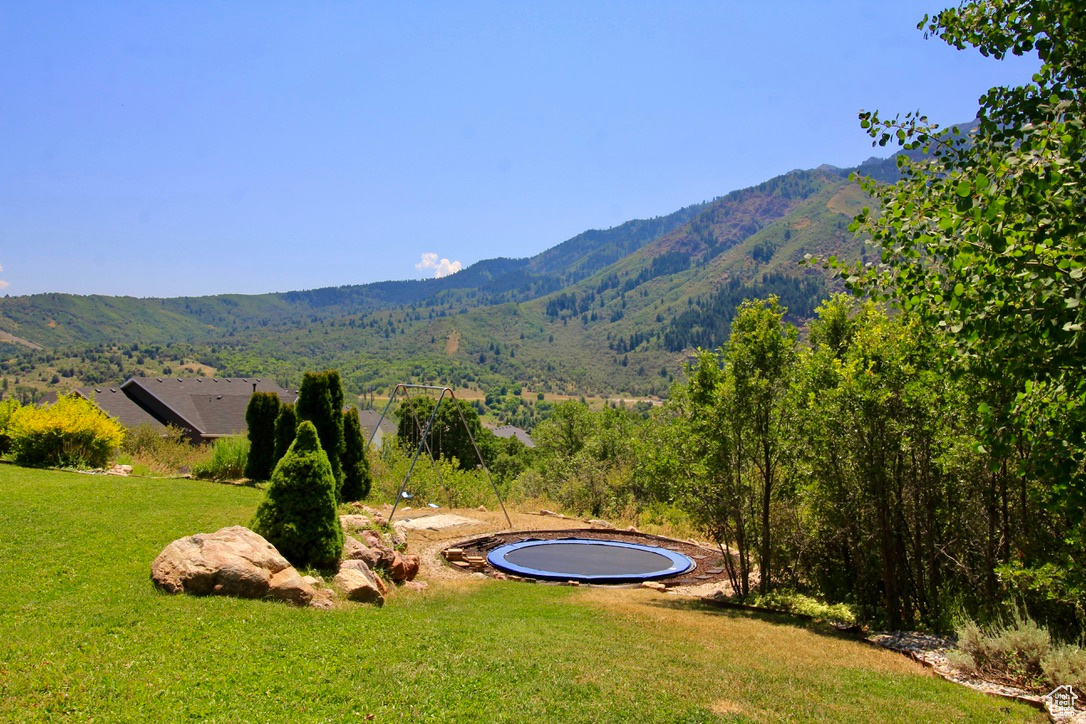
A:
487;538;695;584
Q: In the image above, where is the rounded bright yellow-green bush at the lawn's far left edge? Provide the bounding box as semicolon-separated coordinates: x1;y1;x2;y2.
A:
8;395;125;468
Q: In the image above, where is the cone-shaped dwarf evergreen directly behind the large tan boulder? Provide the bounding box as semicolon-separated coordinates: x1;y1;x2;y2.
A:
253;420;343;569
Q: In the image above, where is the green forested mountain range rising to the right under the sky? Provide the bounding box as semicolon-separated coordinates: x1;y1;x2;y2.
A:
0;158;895;395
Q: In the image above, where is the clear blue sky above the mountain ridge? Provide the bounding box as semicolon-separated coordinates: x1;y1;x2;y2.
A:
0;0;1036;296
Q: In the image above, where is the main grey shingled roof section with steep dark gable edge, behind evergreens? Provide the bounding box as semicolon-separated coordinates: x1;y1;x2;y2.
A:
121;377;298;437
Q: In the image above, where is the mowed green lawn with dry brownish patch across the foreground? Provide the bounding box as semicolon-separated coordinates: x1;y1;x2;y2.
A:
0;465;1045;722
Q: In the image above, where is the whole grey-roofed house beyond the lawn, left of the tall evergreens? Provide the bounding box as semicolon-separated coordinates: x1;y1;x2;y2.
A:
76;377;298;443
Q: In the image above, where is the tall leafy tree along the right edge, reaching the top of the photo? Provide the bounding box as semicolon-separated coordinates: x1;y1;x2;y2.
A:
842;0;1086;633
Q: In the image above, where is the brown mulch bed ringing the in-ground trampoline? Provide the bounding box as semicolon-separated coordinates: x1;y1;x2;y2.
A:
442;528;728;588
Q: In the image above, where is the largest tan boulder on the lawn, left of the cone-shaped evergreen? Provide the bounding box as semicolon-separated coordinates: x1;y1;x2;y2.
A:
151;525;315;606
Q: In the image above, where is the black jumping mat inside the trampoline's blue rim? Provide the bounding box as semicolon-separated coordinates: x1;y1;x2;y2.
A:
505;543;671;575
